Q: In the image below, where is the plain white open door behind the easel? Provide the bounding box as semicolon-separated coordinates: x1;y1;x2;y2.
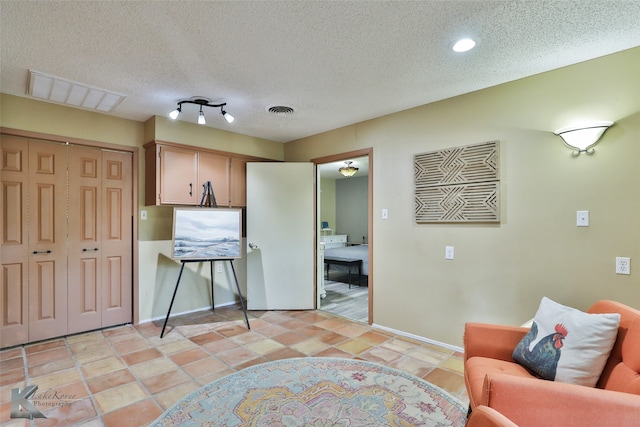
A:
247;162;315;310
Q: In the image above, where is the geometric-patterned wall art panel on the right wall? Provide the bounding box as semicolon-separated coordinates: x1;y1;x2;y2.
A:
414;141;500;223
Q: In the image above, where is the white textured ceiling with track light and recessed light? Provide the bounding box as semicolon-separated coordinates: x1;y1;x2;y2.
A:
0;0;640;142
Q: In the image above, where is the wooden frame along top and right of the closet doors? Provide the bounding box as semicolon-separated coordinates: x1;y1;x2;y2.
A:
0;127;140;325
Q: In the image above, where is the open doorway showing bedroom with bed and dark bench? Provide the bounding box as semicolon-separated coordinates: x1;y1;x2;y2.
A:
314;150;373;324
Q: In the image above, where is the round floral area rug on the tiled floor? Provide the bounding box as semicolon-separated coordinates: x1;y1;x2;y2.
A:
151;357;466;427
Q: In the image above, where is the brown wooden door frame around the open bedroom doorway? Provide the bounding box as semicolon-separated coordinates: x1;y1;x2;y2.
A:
311;147;374;325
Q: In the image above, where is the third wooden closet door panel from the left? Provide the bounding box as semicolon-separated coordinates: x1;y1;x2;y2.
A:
68;146;104;333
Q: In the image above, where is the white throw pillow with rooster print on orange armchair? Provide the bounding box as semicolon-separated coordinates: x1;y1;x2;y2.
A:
513;297;620;387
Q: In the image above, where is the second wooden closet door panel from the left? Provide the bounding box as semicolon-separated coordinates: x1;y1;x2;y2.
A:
23;140;67;341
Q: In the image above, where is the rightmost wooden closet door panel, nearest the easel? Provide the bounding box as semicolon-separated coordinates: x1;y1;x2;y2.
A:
101;151;133;327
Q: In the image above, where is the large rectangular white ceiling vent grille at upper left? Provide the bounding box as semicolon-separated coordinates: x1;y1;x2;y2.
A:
27;70;126;113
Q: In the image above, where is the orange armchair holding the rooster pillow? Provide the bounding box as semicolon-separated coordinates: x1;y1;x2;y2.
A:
464;301;640;427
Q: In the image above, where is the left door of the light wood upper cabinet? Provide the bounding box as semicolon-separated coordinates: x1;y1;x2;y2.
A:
160;147;200;205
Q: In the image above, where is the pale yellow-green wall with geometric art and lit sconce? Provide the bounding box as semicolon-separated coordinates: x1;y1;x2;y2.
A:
285;48;640;345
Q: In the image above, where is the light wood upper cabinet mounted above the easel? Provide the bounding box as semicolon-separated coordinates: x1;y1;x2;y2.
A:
144;141;258;207
